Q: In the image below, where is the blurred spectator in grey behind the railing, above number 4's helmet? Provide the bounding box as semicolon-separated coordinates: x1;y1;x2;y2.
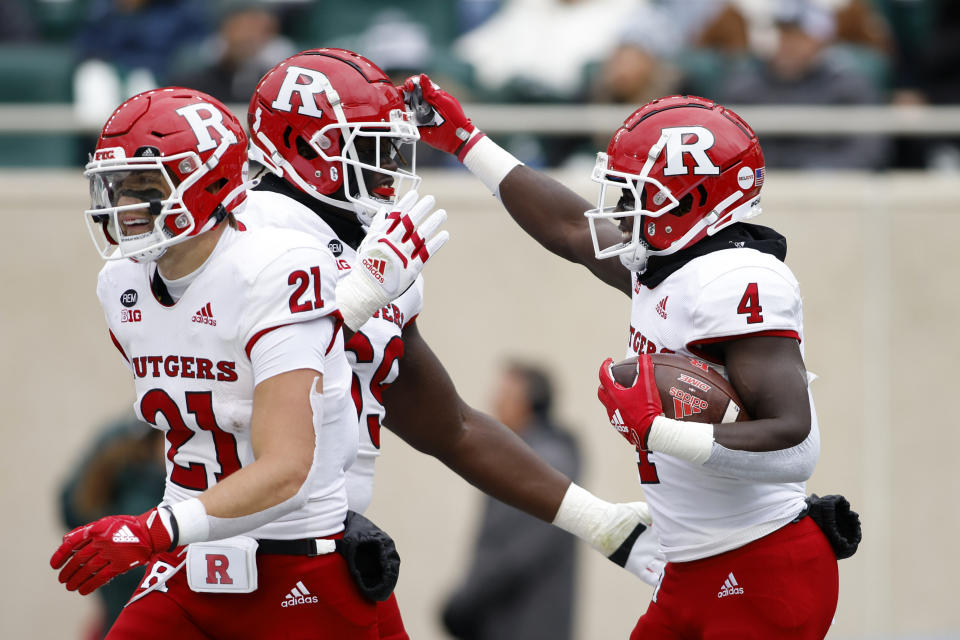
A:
711;0;888;169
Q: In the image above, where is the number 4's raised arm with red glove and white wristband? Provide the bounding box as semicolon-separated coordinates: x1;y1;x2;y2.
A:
403;74;630;295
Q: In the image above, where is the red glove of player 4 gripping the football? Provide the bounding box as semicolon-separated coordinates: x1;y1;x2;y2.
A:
597;355;663;449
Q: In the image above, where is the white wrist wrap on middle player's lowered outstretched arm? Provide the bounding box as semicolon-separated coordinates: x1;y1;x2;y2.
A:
553;482;650;556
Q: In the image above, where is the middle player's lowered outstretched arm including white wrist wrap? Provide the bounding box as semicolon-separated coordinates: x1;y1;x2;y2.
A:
383;322;658;582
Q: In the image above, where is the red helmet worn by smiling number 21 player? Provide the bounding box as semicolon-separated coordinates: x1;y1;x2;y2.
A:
84;87;247;260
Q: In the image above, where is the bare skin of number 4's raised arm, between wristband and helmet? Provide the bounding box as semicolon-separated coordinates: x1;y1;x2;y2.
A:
500;165;631;296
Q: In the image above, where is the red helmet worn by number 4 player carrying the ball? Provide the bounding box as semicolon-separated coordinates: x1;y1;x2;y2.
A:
585;96;765;271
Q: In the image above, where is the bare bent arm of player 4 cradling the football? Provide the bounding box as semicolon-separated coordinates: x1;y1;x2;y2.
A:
704;336;811;451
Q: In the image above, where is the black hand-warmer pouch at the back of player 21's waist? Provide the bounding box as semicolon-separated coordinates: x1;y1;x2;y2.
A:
337;511;400;602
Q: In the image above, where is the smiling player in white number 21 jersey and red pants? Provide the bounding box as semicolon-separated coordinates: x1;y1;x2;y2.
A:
51;87;436;640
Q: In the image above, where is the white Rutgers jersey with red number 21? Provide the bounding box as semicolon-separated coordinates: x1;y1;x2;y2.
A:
97;228;357;539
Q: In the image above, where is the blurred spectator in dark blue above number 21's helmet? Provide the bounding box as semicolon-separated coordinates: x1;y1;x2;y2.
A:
74;0;210;125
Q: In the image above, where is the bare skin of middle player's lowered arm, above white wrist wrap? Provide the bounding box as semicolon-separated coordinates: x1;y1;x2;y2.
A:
383;321;570;522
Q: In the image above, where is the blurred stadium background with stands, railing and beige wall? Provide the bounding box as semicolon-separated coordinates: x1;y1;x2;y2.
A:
0;0;960;640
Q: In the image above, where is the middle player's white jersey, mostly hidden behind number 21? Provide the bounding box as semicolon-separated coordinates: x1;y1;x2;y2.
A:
238;191;423;513
